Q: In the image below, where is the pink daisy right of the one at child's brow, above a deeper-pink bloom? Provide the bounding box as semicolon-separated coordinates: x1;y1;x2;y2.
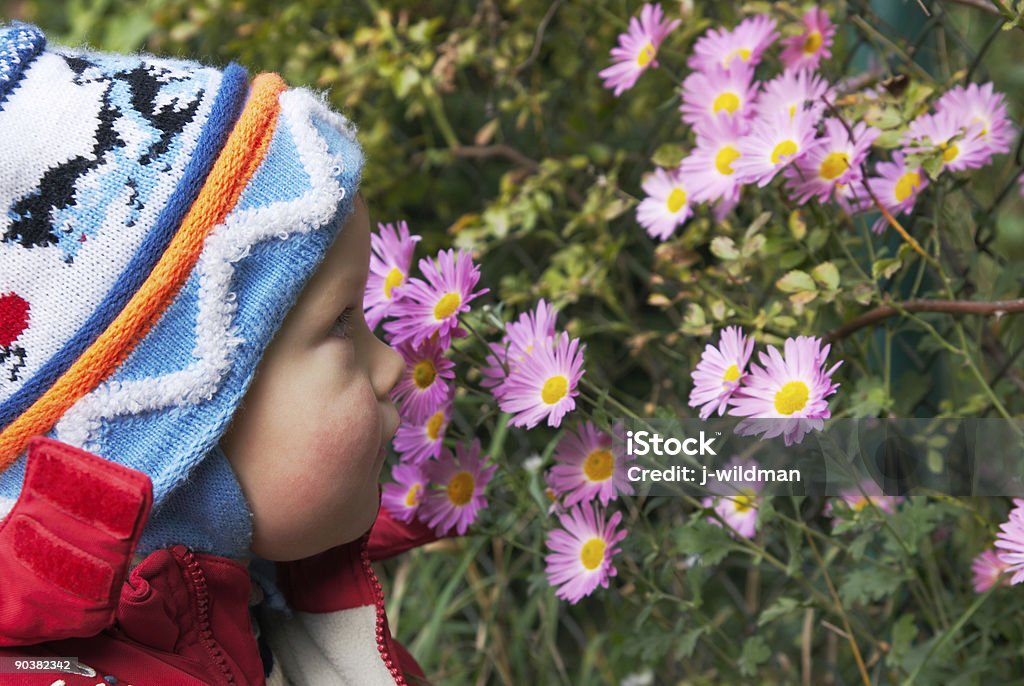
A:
384;250;489;349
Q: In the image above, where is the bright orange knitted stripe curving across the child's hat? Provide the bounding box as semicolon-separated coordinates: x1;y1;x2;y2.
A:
0;74;287;471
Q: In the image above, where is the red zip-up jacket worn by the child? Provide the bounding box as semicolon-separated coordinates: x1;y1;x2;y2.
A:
0;439;434;686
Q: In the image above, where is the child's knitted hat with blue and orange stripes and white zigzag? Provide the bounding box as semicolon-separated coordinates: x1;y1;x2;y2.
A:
0;24;362;555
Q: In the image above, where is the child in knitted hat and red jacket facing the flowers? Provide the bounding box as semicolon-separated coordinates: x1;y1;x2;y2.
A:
0;25;432;686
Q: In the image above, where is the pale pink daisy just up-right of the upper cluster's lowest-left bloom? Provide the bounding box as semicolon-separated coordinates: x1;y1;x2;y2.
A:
679;117;743;204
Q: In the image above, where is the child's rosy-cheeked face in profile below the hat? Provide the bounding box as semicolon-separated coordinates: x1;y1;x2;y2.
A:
220;198;403;560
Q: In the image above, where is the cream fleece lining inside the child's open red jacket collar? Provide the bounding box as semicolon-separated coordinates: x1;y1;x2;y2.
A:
261;605;395;686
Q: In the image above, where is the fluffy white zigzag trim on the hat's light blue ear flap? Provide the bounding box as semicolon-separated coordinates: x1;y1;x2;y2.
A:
56;89;360;473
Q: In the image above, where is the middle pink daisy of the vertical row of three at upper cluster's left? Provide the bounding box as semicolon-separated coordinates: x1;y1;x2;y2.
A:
679;65;758;132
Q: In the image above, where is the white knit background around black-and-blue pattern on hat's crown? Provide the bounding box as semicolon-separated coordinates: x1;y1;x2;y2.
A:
0;52;221;402
